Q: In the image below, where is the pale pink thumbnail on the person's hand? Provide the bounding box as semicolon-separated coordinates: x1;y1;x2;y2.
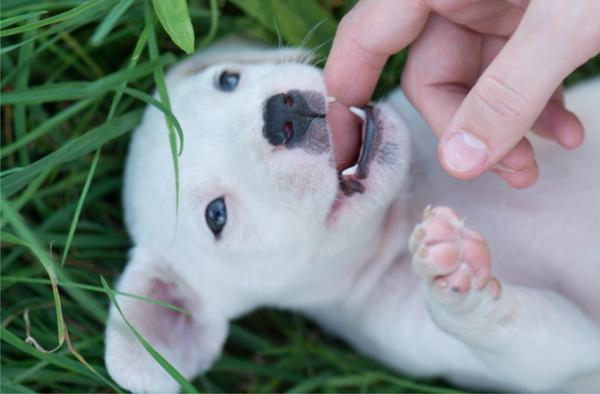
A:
443;130;489;172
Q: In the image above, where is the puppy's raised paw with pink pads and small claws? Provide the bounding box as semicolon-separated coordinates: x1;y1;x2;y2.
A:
409;207;501;305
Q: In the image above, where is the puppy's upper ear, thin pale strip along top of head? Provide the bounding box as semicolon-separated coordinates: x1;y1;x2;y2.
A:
167;36;310;82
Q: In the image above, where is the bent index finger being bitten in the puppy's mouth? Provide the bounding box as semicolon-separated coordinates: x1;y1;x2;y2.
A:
324;0;428;170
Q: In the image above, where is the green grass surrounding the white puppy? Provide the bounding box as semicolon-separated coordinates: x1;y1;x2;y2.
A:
0;0;600;392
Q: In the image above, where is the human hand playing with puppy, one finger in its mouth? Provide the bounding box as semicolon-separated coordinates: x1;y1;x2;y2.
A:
325;0;600;188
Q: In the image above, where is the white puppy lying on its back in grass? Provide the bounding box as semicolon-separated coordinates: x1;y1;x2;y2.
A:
106;42;600;392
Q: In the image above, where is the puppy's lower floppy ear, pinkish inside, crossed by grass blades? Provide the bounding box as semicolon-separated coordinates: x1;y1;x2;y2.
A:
105;248;227;392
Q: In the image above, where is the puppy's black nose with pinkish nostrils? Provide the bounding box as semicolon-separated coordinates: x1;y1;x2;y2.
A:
263;90;325;147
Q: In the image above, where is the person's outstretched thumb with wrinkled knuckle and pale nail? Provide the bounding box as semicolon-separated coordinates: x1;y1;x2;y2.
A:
439;0;584;178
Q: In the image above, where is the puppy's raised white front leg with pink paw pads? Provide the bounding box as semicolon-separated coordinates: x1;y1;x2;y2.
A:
410;207;600;390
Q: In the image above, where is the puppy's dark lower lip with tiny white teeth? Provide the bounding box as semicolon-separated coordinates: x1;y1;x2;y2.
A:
338;105;377;197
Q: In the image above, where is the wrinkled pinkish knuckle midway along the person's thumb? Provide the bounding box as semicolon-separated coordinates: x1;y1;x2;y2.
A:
473;75;531;124
